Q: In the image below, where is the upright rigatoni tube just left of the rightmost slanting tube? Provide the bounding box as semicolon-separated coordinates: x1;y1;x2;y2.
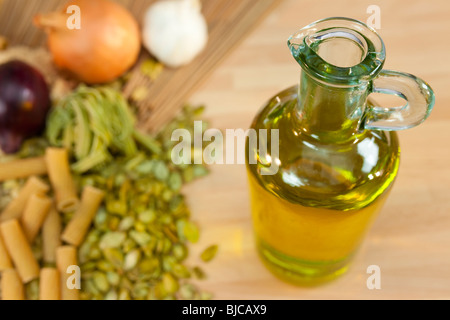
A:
42;206;62;263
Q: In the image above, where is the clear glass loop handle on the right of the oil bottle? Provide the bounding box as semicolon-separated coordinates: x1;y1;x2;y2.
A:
361;70;435;131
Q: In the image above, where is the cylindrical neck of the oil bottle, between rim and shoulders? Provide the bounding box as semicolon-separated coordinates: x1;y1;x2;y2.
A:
297;71;369;142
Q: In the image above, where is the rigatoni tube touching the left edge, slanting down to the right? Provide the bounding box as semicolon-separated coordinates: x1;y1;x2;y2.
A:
0;219;39;283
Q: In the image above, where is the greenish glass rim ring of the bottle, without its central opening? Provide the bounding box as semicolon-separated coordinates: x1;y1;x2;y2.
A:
288;17;386;86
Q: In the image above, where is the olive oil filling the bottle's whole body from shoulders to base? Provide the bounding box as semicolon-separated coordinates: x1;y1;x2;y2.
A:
247;87;400;285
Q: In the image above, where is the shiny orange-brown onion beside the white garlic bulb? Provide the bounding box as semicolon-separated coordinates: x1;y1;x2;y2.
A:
34;0;141;84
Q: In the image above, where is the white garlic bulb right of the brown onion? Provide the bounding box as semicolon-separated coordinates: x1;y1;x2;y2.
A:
142;0;208;68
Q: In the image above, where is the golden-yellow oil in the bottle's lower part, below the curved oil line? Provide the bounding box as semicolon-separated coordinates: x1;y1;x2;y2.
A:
249;171;392;285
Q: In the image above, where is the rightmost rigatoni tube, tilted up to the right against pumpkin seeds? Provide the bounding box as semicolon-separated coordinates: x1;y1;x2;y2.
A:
61;186;105;246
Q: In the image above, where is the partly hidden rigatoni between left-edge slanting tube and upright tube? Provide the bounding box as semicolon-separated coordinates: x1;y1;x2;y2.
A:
20;194;52;243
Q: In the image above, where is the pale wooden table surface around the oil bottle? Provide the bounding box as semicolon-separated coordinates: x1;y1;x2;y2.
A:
186;0;450;299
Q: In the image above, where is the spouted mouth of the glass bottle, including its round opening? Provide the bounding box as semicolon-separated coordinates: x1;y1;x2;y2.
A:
288;17;385;86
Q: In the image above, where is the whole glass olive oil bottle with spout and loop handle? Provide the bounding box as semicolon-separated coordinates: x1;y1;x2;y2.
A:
246;18;434;285
